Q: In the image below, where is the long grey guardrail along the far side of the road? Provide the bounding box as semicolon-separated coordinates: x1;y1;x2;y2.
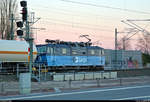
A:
0;76;150;96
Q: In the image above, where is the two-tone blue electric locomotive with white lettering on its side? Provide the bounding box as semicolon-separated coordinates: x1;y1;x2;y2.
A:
35;40;105;69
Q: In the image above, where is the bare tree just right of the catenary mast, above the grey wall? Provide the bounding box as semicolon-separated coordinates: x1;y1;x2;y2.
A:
117;36;131;50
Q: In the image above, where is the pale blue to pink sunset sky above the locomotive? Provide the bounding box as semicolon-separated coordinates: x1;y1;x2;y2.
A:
18;0;150;49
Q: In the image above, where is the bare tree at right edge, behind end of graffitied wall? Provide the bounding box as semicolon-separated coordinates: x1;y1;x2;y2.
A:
137;34;150;54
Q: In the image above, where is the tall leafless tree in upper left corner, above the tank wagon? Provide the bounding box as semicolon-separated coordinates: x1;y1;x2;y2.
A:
0;0;17;40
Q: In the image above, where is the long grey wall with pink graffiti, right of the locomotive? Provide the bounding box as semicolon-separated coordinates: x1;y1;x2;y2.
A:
105;49;143;69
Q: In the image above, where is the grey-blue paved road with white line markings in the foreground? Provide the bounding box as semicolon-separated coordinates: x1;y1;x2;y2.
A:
0;85;150;100
